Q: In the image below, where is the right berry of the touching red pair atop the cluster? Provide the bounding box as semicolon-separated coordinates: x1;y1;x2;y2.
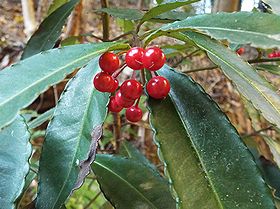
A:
143;46;166;71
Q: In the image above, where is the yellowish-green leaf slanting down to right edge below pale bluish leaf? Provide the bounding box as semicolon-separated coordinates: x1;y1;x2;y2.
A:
186;32;280;131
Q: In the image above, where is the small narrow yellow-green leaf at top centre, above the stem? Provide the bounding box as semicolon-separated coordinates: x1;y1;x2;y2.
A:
140;0;199;23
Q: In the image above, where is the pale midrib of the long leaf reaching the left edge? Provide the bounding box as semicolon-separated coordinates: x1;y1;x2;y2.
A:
0;49;104;107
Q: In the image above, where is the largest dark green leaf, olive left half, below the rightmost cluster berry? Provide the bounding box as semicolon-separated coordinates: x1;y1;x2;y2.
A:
148;66;275;209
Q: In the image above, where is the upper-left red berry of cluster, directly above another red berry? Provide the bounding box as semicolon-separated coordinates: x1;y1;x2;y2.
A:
99;52;120;74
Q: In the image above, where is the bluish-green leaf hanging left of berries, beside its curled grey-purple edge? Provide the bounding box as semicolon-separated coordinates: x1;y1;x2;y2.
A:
36;58;109;209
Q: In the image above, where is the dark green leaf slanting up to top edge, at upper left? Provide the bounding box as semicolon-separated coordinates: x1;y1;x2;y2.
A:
21;0;79;59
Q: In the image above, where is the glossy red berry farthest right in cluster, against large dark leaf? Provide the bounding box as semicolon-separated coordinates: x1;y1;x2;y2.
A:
146;76;170;99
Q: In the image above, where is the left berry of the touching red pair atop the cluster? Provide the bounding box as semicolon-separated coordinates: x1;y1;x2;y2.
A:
125;47;145;70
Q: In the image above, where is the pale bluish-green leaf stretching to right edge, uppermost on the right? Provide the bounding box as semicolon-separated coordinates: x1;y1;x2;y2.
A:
149;12;280;48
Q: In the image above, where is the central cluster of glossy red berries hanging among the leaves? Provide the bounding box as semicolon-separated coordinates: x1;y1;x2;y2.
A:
93;47;170;122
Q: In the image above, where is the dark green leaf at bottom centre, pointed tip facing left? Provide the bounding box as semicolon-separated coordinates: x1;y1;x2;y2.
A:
92;155;176;209
